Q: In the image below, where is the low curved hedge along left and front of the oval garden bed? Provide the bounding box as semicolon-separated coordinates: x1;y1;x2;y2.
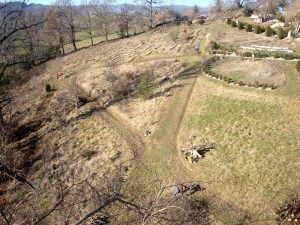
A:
202;56;276;89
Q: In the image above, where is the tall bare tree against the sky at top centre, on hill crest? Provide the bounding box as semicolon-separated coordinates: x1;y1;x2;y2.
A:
135;0;164;28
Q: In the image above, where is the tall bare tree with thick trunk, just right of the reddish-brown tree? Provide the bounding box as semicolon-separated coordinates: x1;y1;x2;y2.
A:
55;0;78;51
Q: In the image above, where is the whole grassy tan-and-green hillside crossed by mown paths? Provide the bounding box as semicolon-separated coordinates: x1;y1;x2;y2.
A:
2;18;300;224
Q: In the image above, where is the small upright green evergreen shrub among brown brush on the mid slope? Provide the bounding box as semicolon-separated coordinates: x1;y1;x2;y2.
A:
137;70;153;98
